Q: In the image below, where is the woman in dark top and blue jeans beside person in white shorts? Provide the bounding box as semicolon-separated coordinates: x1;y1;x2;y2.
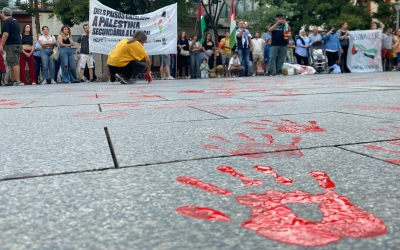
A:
57;25;79;83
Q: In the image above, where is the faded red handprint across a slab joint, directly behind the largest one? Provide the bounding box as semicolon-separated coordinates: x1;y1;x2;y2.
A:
202;133;303;158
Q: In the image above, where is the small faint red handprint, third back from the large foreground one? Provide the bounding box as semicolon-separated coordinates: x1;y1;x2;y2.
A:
245;119;326;133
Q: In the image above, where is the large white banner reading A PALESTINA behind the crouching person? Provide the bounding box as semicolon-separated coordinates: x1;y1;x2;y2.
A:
89;0;178;55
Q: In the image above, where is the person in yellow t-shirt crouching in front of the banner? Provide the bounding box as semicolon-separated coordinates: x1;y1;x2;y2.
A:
107;31;152;84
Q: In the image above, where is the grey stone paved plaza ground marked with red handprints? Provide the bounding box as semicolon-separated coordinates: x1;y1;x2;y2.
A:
0;72;400;250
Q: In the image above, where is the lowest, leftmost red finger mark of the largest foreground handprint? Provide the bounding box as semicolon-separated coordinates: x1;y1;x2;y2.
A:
176;206;230;221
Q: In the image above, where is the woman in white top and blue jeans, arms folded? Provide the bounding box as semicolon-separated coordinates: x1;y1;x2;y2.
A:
39;26;57;84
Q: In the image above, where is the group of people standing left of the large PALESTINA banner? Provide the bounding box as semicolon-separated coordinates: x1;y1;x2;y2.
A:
0;7;95;86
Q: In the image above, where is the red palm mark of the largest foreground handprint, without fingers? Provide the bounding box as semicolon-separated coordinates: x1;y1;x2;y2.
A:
235;190;387;247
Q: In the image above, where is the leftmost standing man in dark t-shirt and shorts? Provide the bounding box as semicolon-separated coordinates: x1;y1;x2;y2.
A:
0;7;24;86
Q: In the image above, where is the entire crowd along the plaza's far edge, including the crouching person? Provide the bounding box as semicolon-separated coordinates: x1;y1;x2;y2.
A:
0;7;400;86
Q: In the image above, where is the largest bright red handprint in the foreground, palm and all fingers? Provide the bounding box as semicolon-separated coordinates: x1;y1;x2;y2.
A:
176;166;387;246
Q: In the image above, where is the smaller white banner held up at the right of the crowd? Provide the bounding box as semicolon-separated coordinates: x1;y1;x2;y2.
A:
347;30;382;73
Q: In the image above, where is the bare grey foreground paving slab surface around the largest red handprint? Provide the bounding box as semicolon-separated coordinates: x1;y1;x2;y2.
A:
0;148;400;249
